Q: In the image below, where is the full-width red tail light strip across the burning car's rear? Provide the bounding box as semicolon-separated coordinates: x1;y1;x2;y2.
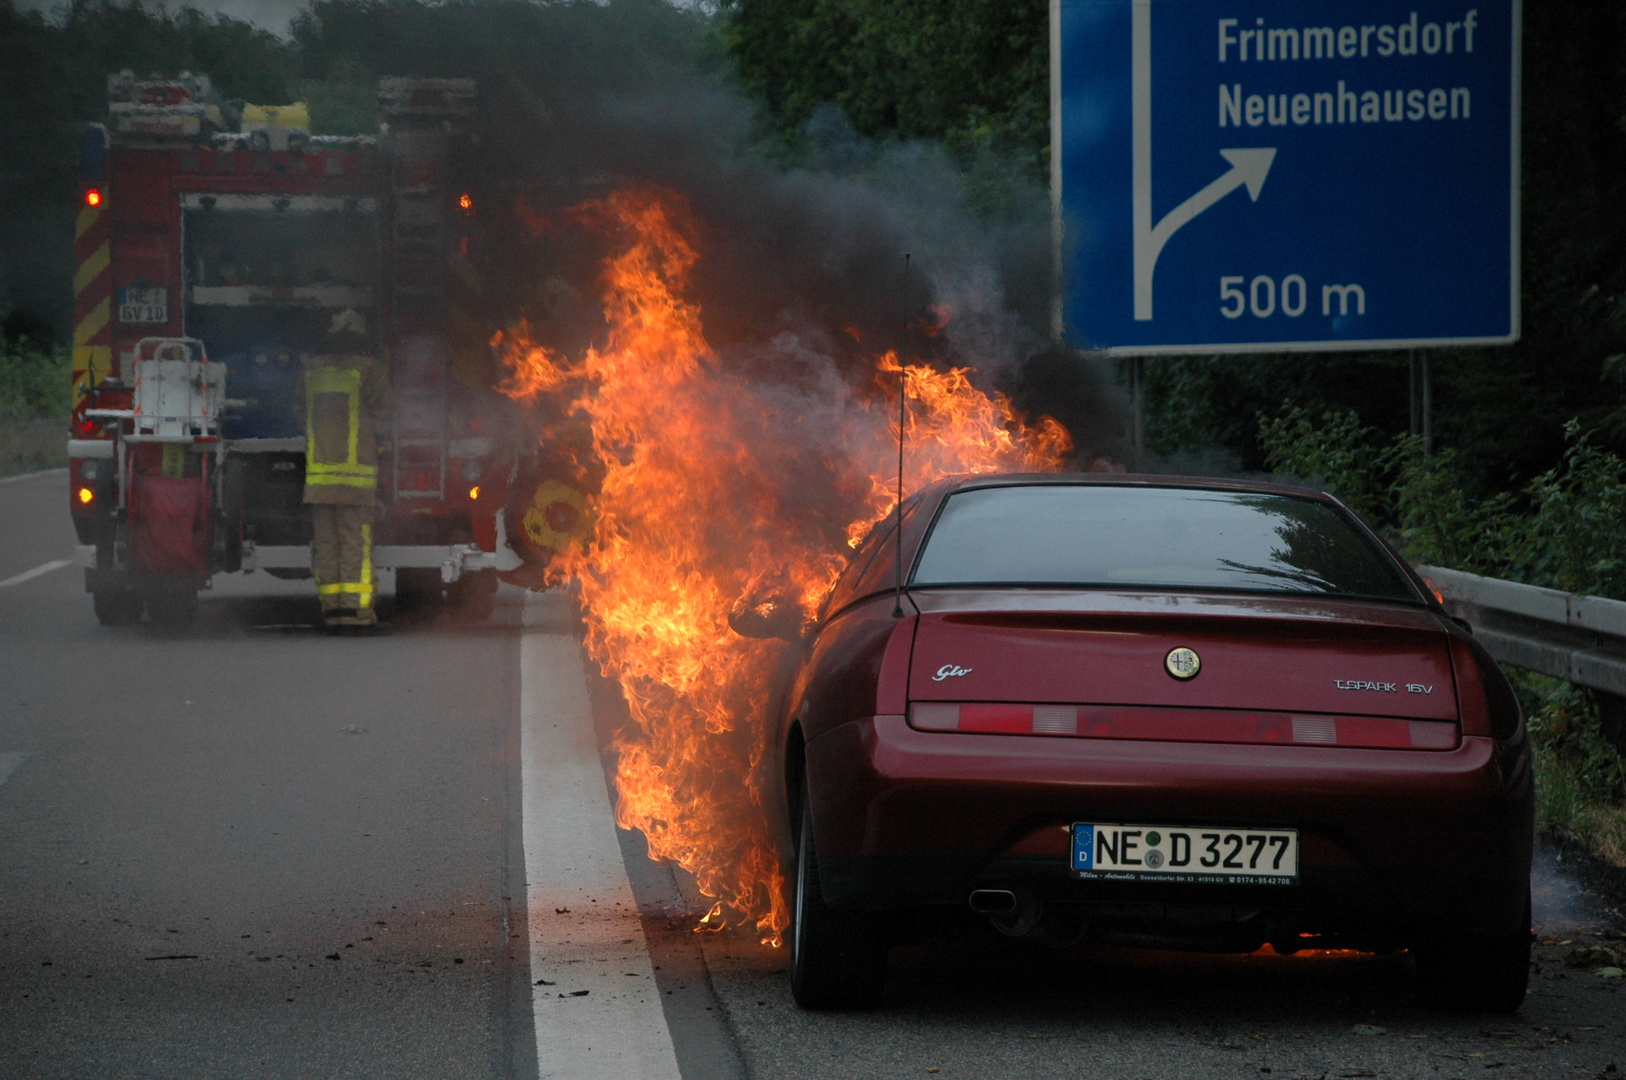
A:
909;701;1457;750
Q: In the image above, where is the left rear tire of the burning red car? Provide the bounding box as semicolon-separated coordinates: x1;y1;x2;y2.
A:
790;780;888;1008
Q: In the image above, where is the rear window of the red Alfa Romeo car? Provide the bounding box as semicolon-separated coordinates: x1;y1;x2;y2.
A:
911;485;1421;602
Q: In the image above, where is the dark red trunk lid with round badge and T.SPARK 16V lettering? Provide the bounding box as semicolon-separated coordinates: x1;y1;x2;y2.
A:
909;590;1457;725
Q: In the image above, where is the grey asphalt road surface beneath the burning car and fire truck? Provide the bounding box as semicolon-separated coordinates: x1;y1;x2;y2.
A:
0;473;1626;1080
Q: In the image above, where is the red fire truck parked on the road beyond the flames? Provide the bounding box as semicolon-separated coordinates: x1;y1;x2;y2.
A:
68;72;565;625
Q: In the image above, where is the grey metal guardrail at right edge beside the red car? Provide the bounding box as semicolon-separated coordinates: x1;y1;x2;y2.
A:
1416;566;1626;698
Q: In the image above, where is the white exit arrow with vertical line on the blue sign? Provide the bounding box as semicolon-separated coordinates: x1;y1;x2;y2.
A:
1130;0;1276;322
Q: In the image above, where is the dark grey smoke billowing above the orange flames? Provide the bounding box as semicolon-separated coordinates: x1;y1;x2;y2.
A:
448;14;1120;462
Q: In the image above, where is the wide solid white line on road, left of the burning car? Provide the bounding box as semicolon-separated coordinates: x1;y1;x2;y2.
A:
520;594;681;1080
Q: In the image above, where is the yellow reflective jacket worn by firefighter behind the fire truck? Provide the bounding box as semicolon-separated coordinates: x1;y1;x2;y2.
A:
298;356;389;506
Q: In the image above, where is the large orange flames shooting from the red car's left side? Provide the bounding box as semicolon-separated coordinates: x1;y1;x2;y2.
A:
496;187;1072;942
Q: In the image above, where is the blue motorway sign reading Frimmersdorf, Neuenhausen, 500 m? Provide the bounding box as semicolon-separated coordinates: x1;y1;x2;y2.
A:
1052;0;1520;355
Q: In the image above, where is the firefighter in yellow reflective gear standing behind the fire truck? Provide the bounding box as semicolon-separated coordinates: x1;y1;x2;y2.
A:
298;309;387;628
